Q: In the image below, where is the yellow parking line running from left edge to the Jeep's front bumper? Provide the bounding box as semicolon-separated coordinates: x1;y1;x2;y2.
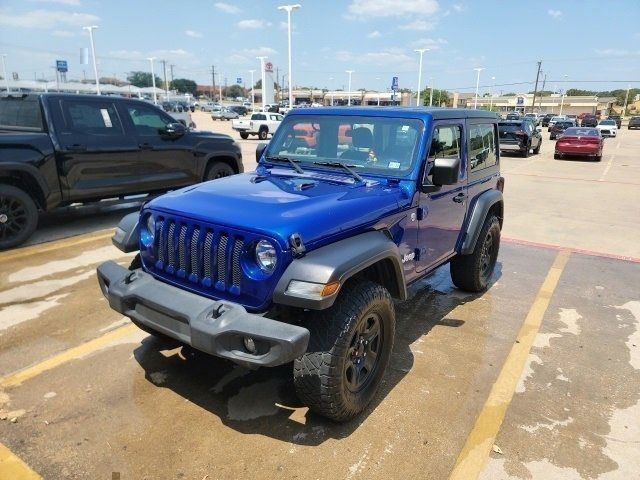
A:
0;324;138;388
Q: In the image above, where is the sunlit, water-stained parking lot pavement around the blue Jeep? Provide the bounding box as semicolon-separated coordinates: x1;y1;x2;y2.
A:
0;112;640;480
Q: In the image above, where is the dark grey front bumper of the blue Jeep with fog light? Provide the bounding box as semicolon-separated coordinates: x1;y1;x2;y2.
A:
98;261;309;367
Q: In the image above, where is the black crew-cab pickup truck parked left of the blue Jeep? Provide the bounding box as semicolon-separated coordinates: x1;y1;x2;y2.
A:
0;94;243;249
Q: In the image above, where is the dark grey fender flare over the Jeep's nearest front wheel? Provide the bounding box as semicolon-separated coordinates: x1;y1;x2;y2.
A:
273;231;407;310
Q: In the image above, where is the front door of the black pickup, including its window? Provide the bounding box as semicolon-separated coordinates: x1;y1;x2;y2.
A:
123;102;202;192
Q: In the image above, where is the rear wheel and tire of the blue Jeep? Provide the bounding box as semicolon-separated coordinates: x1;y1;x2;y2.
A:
449;215;500;292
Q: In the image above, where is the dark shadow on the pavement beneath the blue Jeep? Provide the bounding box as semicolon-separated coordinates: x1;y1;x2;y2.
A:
134;262;502;446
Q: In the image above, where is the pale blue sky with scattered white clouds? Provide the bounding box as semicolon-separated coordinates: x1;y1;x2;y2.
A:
0;0;640;93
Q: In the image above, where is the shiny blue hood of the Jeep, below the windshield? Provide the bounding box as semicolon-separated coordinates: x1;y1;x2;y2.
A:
146;169;407;249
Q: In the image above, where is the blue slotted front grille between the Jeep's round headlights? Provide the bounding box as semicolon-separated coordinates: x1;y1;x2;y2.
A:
154;218;245;295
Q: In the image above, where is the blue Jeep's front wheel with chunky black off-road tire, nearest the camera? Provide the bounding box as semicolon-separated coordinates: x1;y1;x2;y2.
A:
293;280;395;422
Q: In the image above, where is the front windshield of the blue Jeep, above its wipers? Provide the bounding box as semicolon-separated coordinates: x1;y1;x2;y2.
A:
266;115;424;175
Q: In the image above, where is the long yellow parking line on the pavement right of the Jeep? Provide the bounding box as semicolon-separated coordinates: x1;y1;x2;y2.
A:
449;250;571;480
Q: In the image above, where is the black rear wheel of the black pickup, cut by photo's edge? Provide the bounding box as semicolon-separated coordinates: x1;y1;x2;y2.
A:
0;185;38;250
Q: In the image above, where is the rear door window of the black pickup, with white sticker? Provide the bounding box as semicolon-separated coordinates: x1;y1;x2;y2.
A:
62;99;123;136
